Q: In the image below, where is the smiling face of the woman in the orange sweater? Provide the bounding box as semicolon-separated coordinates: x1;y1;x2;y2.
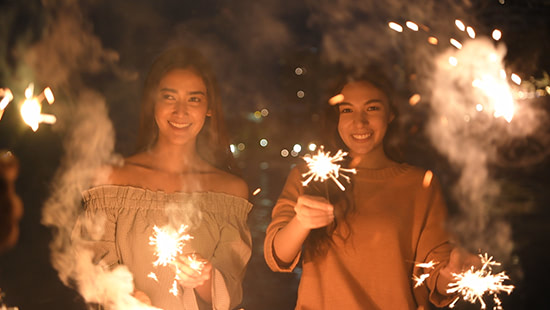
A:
338;81;394;157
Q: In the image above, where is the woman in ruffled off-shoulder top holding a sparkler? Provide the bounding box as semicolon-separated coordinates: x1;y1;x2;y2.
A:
83;48;251;310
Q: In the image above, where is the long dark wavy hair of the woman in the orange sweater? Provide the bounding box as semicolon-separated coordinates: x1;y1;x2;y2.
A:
304;66;402;257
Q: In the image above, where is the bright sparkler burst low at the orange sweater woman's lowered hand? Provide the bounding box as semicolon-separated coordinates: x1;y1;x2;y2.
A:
447;253;514;310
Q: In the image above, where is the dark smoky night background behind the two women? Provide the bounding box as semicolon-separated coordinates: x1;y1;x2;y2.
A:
0;0;550;310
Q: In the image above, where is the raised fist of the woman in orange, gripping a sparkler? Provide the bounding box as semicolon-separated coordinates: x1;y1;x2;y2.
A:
294;195;334;229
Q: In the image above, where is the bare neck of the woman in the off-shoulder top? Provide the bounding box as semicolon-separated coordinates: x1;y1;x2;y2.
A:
148;141;203;173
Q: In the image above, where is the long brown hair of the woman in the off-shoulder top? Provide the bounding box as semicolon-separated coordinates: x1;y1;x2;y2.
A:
137;47;238;174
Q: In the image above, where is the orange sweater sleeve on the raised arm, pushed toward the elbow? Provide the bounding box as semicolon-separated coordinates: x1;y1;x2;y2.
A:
264;168;303;272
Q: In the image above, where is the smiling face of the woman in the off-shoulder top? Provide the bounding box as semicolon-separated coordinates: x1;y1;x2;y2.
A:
154;69;210;147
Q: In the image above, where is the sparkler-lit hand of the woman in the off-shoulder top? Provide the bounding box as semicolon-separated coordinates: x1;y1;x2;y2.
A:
176;254;212;288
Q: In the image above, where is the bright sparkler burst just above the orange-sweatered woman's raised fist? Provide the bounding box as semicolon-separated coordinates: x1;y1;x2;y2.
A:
302;146;357;191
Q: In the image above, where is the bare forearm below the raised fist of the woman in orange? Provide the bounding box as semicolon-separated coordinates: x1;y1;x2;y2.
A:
273;217;310;265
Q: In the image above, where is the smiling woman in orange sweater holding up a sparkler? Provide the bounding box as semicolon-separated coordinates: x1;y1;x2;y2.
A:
264;69;476;310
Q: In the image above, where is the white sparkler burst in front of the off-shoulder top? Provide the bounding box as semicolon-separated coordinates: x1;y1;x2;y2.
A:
149;225;193;266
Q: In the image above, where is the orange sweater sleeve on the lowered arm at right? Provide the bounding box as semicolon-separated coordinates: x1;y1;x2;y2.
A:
413;177;455;307
